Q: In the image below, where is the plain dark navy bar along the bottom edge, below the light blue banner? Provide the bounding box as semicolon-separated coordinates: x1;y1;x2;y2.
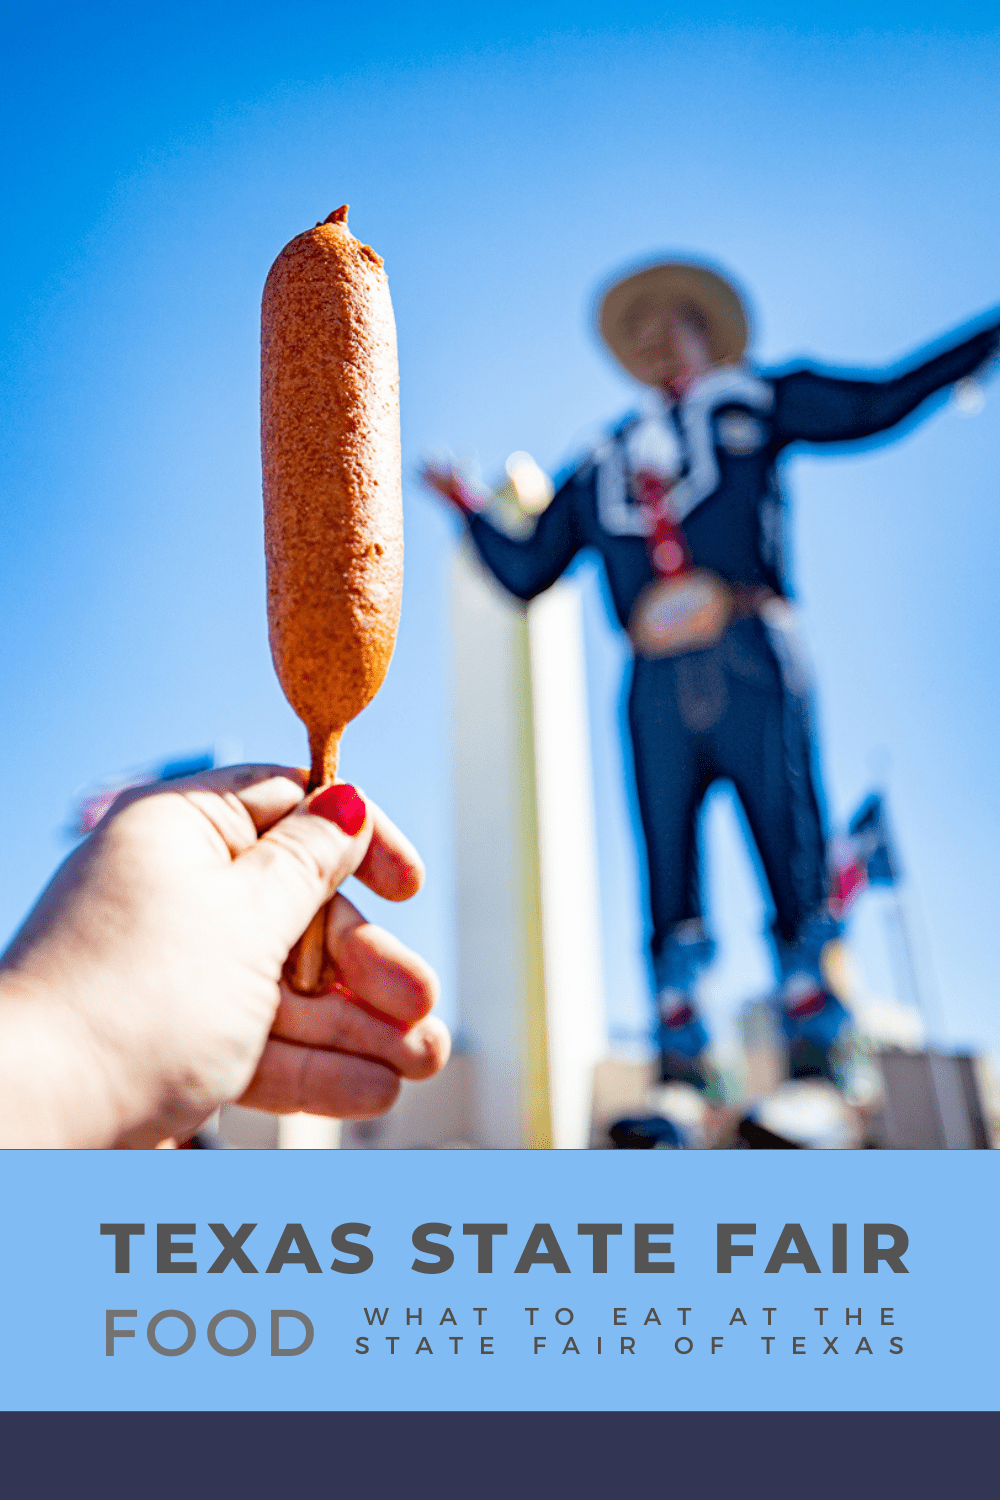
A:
0;1412;1000;1500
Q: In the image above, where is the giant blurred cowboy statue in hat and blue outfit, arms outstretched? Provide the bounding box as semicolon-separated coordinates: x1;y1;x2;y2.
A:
424;261;1000;1128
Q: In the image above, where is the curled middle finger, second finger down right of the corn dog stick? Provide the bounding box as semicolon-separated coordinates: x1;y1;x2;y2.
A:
327;896;438;1028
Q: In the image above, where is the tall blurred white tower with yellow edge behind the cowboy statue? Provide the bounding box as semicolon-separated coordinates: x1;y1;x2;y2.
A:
454;543;606;1148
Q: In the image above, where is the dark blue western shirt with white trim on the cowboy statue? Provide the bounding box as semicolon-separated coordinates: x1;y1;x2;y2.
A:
469;313;1000;626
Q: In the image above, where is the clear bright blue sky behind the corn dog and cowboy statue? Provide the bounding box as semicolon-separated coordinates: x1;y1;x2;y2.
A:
0;0;1000;1047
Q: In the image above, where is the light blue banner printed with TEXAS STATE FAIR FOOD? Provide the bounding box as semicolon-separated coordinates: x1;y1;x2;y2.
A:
0;1151;1000;1412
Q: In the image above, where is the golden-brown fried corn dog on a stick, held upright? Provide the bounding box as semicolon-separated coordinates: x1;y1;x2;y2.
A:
261;204;403;990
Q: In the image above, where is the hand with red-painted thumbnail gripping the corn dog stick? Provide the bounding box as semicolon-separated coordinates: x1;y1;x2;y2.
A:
0;767;448;1146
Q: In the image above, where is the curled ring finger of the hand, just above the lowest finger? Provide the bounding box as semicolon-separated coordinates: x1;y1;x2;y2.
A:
271;986;451;1080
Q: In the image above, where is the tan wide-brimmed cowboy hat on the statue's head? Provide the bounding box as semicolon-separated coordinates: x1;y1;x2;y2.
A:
597;261;750;380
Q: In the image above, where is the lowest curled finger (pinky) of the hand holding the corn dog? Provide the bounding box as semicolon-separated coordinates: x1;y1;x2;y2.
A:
238;1040;400;1121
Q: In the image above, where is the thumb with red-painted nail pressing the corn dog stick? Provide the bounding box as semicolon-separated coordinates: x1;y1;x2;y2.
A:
232;782;373;953
